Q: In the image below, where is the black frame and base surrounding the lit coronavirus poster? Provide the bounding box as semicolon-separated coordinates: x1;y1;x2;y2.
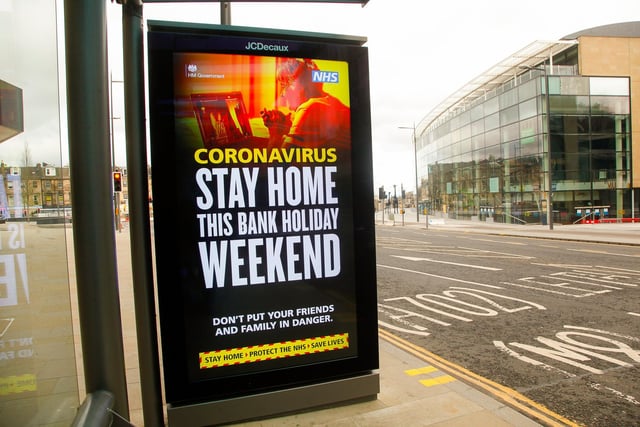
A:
148;21;379;425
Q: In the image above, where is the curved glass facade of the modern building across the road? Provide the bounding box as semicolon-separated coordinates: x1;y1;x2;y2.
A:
418;66;631;223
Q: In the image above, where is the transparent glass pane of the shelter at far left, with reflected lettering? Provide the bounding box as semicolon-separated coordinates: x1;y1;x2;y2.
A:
0;0;79;426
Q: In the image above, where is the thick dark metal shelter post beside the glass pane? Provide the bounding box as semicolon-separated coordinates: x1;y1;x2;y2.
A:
64;0;129;418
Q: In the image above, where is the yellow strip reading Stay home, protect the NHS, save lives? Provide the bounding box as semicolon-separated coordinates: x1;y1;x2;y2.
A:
199;333;349;369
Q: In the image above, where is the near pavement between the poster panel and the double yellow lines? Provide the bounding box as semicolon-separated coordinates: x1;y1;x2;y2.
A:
237;339;541;427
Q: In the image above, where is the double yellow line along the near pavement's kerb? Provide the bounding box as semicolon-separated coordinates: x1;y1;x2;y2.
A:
378;328;580;427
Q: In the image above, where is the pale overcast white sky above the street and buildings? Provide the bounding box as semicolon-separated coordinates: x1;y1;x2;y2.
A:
0;0;640;194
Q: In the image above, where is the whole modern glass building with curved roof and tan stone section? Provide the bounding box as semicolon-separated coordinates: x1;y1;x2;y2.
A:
416;22;640;224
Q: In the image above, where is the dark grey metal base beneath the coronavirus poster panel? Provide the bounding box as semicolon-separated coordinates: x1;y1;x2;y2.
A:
167;372;380;427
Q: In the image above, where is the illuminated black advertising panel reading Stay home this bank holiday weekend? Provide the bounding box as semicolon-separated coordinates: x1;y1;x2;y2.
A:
148;23;378;404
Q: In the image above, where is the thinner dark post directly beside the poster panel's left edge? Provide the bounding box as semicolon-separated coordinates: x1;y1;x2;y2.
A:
122;0;164;427
